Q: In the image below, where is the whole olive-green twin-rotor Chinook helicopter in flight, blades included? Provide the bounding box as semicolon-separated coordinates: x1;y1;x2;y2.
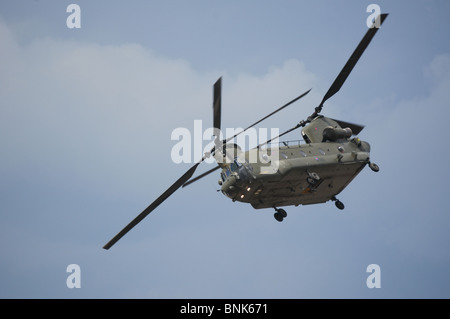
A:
103;13;388;249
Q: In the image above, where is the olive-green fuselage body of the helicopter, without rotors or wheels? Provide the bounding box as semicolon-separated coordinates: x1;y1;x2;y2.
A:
219;137;370;209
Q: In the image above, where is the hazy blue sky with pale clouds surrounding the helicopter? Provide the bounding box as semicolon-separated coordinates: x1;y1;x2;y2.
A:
0;0;450;298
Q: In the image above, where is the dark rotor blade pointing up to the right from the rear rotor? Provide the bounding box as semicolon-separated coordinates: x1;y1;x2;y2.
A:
317;13;388;109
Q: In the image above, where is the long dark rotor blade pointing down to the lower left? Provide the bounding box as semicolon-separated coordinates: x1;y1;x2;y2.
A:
103;162;201;249
